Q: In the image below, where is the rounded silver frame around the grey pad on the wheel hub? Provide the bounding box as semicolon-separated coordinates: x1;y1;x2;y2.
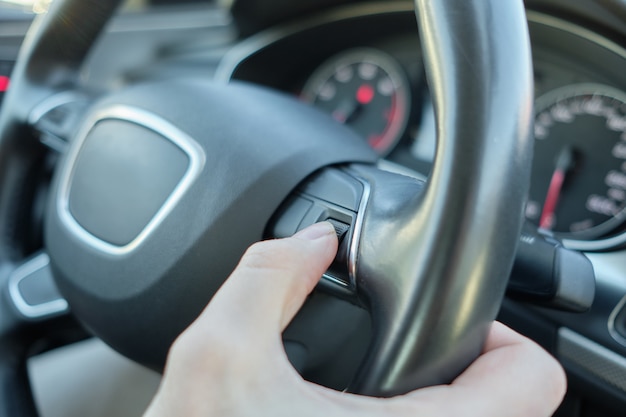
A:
56;105;206;256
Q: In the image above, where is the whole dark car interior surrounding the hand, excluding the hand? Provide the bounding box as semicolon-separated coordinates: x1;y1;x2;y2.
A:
0;0;626;417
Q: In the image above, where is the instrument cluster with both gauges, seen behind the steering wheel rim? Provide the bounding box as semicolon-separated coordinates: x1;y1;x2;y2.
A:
217;3;626;250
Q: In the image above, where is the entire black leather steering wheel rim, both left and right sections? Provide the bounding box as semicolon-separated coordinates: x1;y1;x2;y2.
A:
0;0;532;415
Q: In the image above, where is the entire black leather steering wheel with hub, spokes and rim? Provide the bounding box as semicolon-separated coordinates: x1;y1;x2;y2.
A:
0;0;533;416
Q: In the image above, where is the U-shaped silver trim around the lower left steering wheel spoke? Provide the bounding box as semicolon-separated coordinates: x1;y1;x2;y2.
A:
9;253;69;320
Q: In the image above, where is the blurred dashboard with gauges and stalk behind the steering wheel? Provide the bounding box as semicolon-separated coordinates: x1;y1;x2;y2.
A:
0;1;626;417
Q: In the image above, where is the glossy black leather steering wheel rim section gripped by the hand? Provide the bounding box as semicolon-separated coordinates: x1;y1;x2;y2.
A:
352;0;533;396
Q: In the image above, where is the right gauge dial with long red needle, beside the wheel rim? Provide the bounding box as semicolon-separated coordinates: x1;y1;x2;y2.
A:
526;84;626;239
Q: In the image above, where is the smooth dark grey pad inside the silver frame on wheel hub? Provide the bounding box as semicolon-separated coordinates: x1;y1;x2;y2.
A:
69;119;189;247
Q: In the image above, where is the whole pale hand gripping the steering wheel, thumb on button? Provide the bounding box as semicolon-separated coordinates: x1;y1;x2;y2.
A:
145;222;566;417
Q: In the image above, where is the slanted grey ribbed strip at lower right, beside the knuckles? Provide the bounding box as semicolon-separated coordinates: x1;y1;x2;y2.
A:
557;327;626;392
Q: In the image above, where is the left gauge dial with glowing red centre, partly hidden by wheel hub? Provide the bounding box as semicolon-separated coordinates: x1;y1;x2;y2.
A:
302;49;410;156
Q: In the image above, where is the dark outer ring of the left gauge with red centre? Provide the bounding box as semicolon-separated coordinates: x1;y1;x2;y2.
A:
300;47;411;158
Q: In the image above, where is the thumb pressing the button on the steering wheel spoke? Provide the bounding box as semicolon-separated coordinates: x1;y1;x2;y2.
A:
191;222;337;341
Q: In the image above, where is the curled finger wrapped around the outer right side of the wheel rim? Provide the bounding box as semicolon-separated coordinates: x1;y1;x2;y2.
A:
404;323;566;417
